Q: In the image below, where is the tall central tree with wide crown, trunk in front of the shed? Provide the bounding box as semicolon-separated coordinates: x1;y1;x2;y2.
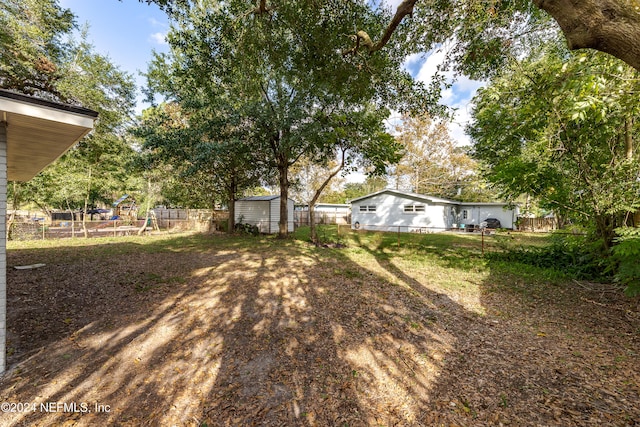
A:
149;0;426;236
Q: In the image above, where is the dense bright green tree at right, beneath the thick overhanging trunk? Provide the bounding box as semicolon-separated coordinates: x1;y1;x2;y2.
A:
468;45;640;248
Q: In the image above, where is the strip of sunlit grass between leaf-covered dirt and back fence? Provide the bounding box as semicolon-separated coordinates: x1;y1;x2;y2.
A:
8;225;592;314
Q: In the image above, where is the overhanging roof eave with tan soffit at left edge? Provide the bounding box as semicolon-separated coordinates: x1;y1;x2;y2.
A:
0;89;98;181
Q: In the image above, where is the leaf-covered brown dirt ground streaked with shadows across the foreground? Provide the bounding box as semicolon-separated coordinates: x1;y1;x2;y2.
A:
0;237;640;427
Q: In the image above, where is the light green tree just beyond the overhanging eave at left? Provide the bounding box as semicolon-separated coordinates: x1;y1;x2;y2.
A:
21;32;138;213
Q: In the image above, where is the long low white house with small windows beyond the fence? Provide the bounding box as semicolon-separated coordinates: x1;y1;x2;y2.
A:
351;190;518;233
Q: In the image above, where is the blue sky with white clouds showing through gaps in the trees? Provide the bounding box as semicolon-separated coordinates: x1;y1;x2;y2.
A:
60;0;483;145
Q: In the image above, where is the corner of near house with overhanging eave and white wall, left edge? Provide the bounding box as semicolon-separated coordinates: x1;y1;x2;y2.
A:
0;90;98;373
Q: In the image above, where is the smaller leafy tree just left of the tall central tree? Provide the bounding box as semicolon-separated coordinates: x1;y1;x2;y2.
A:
132;99;264;232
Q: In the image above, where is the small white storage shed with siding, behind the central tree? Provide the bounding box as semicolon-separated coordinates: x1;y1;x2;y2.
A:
235;196;294;233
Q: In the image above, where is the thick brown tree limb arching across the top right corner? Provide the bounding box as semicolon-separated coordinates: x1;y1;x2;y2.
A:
533;0;640;70
